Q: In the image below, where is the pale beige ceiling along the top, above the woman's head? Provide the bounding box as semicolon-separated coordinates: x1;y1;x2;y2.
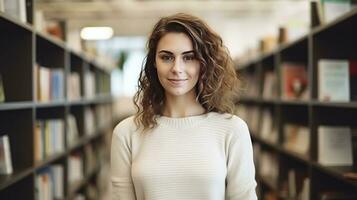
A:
36;0;307;35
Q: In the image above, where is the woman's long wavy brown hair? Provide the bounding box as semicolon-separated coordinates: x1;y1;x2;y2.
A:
133;13;239;130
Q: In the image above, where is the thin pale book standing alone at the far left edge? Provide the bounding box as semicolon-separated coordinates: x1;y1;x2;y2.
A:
0;135;13;174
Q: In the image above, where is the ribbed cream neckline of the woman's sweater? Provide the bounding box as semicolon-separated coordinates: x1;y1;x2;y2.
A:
157;112;211;128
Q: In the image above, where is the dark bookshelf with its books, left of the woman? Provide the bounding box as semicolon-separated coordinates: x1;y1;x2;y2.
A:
0;0;114;200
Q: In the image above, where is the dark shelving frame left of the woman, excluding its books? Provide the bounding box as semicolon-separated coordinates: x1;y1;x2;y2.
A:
0;3;113;200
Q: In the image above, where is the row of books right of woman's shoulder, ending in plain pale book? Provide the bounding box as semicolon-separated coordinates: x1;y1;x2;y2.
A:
236;105;356;166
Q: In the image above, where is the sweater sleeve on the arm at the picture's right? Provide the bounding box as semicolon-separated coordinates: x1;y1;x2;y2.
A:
225;119;257;200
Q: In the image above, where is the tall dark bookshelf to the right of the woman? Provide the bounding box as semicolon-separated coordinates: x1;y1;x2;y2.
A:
236;8;357;199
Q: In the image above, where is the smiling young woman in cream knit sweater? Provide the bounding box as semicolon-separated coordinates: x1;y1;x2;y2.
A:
111;14;257;200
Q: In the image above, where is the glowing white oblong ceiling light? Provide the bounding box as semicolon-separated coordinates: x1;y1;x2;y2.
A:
81;27;114;40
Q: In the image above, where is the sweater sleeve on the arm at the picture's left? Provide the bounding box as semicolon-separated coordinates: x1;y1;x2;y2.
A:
111;124;136;200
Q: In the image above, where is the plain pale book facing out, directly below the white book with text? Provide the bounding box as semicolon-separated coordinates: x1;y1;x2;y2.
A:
318;126;353;166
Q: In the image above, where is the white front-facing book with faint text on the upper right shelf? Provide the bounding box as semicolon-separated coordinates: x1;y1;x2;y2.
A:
318;59;350;102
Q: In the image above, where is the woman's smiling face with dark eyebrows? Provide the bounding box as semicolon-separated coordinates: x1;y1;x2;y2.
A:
155;33;200;98
